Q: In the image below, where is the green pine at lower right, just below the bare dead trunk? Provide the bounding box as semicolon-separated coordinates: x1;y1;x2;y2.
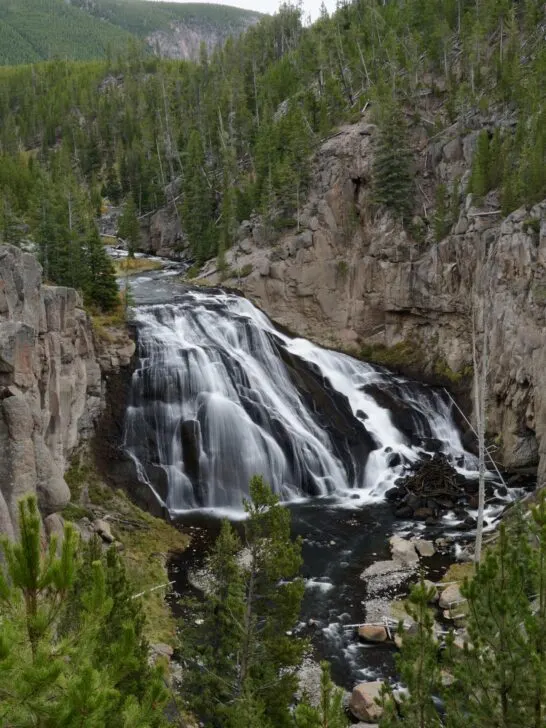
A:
447;519;534;728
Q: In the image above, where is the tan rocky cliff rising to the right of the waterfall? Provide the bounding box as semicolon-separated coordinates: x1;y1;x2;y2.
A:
204;119;546;483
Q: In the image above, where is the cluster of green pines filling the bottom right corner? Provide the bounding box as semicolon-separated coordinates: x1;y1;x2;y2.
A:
380;493;546;728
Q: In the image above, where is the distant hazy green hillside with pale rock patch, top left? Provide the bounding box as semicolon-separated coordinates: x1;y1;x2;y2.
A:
0;0;259;65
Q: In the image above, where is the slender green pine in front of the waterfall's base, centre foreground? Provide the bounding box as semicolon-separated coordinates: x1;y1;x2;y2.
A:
182;476;305;728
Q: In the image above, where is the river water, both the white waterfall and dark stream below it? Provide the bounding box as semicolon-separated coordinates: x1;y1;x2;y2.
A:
119;264;506;688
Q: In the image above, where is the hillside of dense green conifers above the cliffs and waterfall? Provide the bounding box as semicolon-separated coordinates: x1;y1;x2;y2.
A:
0;0;546;308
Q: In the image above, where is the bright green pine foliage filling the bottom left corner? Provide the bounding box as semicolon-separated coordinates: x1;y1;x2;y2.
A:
0;498;167;728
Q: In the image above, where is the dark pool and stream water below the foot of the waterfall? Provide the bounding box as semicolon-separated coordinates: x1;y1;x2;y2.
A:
166;501;448;689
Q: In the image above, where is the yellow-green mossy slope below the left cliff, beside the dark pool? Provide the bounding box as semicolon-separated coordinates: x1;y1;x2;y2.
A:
62;459;189;644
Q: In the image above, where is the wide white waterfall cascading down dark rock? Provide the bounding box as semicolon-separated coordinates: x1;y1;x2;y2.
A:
124;292;474;513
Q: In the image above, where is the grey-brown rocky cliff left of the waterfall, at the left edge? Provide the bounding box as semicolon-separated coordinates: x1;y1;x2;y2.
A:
0;245;134;535
